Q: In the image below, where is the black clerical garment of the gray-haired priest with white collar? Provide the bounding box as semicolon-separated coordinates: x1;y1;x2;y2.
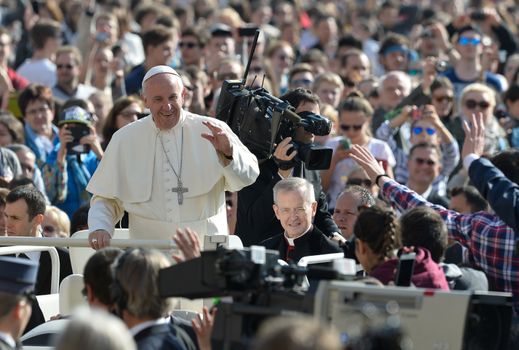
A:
261;226;343;264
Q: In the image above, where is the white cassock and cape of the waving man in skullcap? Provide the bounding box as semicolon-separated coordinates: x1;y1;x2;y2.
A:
87;111;259;242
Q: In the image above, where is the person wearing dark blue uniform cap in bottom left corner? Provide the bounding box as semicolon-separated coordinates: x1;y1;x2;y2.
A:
0;256;38;350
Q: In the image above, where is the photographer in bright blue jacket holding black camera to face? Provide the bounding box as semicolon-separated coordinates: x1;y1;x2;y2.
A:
42;106;103;217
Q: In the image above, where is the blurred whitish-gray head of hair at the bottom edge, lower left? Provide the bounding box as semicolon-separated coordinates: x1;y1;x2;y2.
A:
56;307;137;350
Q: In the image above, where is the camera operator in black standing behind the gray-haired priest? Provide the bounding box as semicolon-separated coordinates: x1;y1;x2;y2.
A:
236;88;340;246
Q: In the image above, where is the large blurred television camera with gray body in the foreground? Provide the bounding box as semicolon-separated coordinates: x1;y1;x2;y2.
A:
159;247;512;350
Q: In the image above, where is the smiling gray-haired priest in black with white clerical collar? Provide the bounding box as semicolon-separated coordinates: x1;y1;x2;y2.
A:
261;177;342;263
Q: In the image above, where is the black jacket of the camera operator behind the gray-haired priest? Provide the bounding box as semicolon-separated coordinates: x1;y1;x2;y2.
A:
236;159;340;247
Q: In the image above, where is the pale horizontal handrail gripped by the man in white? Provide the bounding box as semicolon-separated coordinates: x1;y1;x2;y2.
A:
0;236;177;250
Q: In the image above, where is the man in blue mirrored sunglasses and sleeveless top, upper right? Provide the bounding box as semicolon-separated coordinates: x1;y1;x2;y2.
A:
443;25;504;96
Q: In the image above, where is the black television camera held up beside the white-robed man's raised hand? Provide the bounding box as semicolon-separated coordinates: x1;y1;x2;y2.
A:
216;30;333;170
